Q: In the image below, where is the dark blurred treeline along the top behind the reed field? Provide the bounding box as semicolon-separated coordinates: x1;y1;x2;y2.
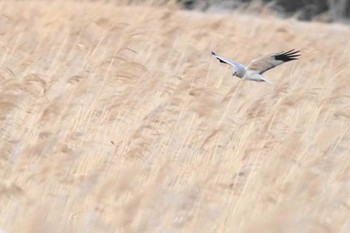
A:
177;0;350;22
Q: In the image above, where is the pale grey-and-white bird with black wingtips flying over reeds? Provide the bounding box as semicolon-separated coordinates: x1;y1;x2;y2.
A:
211;49;300;83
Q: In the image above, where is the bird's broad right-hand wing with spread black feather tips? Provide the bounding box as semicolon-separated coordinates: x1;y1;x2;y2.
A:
247;49;300;74
